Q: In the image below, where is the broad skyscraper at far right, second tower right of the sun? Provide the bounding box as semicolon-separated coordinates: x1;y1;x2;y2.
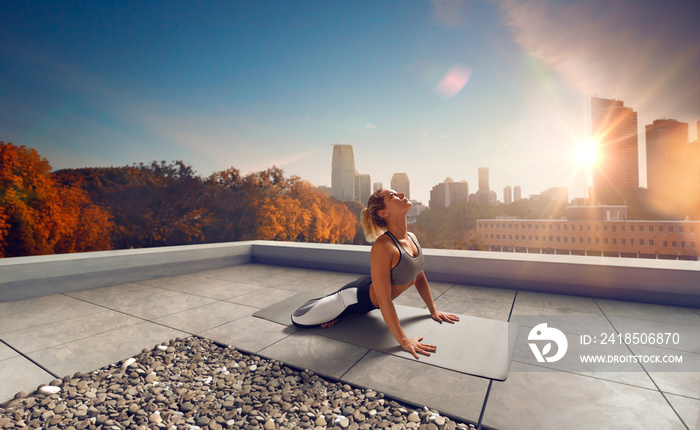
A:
645;119;697;194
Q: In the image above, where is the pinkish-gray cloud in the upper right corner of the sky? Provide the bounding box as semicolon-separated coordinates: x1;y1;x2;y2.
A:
500;0;700;117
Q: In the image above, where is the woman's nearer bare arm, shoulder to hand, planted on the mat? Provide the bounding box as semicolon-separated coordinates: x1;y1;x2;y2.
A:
370;238;435;358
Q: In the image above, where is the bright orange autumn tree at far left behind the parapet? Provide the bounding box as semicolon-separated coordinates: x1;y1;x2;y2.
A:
0;142;113;257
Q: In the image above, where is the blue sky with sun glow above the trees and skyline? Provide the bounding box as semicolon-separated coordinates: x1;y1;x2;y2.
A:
0;0;700;205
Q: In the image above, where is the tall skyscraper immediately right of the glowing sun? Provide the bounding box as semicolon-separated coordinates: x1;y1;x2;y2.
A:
591;97;639;203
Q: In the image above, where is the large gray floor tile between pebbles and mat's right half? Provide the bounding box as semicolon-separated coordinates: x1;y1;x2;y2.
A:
342;351;489;422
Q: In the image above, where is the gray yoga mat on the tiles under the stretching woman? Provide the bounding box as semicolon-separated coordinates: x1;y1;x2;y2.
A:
253;292;518;381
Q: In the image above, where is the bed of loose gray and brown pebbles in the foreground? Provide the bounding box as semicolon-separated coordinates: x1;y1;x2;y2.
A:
0;337;474;430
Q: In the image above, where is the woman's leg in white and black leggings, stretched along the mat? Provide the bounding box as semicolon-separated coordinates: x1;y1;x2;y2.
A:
292;276;372;328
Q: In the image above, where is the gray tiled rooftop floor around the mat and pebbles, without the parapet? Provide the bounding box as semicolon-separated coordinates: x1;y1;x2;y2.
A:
0;264;700;429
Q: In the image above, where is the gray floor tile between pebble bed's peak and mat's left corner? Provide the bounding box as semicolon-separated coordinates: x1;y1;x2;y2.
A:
201;316;298;353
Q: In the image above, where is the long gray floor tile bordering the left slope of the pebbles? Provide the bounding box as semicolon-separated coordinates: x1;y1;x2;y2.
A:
28;322;187;376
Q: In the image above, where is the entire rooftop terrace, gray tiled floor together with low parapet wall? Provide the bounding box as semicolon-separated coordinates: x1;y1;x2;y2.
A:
0;242;700;429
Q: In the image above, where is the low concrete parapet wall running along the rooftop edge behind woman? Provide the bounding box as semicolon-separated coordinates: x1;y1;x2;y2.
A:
0;241;700;307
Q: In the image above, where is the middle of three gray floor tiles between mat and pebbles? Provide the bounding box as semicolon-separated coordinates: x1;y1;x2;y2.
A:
259;331;369;380
